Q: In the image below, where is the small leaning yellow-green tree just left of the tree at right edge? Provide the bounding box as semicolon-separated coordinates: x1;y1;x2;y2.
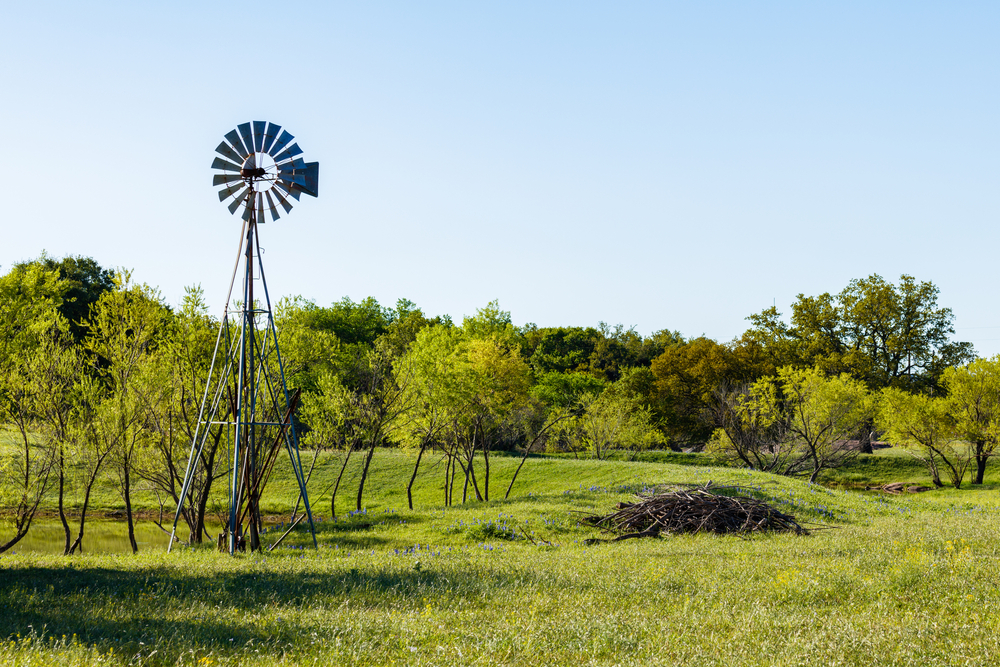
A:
876;387;972;489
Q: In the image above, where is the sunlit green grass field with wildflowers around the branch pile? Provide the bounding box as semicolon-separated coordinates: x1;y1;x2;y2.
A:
0;438;1000;667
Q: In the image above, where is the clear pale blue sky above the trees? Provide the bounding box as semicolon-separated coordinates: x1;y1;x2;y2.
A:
0;1;1000;355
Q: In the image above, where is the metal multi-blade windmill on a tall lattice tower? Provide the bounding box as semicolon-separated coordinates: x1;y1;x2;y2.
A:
167;121;319;554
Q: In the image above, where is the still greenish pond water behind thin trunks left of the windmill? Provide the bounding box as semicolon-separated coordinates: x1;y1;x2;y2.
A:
0;517;221;554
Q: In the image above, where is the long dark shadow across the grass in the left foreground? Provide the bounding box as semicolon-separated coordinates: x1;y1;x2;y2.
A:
0;565;523;664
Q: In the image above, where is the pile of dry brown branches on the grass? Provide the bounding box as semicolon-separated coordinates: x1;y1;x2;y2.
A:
582;482;808;542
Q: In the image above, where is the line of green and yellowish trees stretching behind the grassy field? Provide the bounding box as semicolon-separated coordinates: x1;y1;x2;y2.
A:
0;255;988;554
